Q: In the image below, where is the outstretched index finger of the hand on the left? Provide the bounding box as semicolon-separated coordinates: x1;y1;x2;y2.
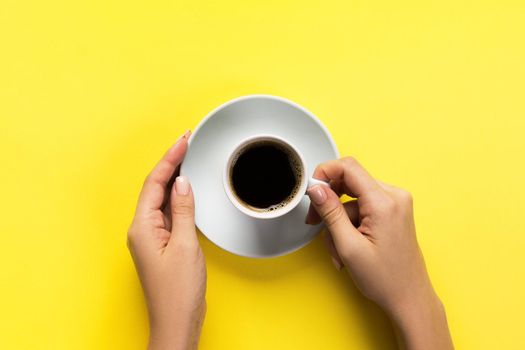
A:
137;131;190;214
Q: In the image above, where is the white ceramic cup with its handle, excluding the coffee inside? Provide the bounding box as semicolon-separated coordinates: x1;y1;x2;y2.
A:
222;134;328;219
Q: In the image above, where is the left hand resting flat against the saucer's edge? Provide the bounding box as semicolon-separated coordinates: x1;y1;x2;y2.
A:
128;132;206;349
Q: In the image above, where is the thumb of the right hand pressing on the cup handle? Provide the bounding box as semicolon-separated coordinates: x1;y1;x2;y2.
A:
307;185;363;256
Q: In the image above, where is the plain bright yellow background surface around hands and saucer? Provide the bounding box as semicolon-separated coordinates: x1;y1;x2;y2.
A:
0;0;525;349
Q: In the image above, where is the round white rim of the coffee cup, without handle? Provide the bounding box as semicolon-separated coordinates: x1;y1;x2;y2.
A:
222;133;308;219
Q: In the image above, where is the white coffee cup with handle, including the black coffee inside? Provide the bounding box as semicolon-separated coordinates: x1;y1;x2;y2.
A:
223;134;328;219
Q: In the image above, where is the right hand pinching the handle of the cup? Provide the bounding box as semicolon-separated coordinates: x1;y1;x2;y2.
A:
306;158;453;350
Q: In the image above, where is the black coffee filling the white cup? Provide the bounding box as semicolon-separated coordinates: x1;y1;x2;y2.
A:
230;141;301;210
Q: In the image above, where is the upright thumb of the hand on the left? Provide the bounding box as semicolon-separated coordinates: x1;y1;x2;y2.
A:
168;176;197;245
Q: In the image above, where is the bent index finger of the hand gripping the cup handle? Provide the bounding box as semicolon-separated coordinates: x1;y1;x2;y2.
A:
313;157;382;199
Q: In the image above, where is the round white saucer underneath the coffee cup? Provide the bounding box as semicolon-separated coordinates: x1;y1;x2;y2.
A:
181;95;338;258
